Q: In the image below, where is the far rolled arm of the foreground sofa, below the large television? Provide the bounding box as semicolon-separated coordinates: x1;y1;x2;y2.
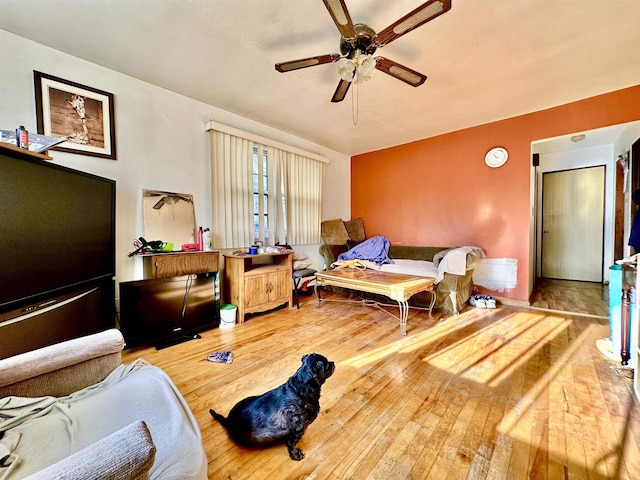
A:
0;329;124;397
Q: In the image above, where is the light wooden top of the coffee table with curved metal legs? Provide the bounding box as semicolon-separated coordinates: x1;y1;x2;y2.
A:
316;268;435;302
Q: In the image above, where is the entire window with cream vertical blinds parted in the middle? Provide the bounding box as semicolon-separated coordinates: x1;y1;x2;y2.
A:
209;127;325;248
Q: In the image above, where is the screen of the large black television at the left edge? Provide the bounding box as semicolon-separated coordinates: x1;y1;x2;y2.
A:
0;152;116;313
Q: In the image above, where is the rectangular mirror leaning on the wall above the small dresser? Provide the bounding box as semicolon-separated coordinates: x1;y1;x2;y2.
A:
142;190;196;250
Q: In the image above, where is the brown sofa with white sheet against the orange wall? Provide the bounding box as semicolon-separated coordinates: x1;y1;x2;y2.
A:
320;218;484;315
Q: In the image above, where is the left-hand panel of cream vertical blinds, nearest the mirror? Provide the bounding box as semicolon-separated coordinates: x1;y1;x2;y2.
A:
210;130;255;248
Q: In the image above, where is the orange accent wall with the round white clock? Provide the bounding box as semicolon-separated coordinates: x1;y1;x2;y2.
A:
351;85;640;301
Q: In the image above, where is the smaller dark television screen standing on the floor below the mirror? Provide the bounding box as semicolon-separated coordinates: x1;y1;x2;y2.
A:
120;272;220;348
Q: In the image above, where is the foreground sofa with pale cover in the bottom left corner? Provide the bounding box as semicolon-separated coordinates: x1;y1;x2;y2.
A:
0;329;207;480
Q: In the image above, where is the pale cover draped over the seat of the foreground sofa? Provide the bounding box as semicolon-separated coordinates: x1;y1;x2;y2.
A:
0;360;207;480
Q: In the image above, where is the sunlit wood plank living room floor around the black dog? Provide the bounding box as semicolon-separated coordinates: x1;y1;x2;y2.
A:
124;294;640;480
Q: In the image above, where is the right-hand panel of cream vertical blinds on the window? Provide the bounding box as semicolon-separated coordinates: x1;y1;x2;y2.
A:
283;152;324;245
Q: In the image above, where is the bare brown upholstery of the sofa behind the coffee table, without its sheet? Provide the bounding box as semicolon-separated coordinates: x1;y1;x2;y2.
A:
320;218;481;314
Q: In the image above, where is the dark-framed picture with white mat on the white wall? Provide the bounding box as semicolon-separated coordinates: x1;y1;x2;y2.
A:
33;70;116;160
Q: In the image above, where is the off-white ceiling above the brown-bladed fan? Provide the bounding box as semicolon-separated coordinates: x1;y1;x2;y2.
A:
0;0;640;155
